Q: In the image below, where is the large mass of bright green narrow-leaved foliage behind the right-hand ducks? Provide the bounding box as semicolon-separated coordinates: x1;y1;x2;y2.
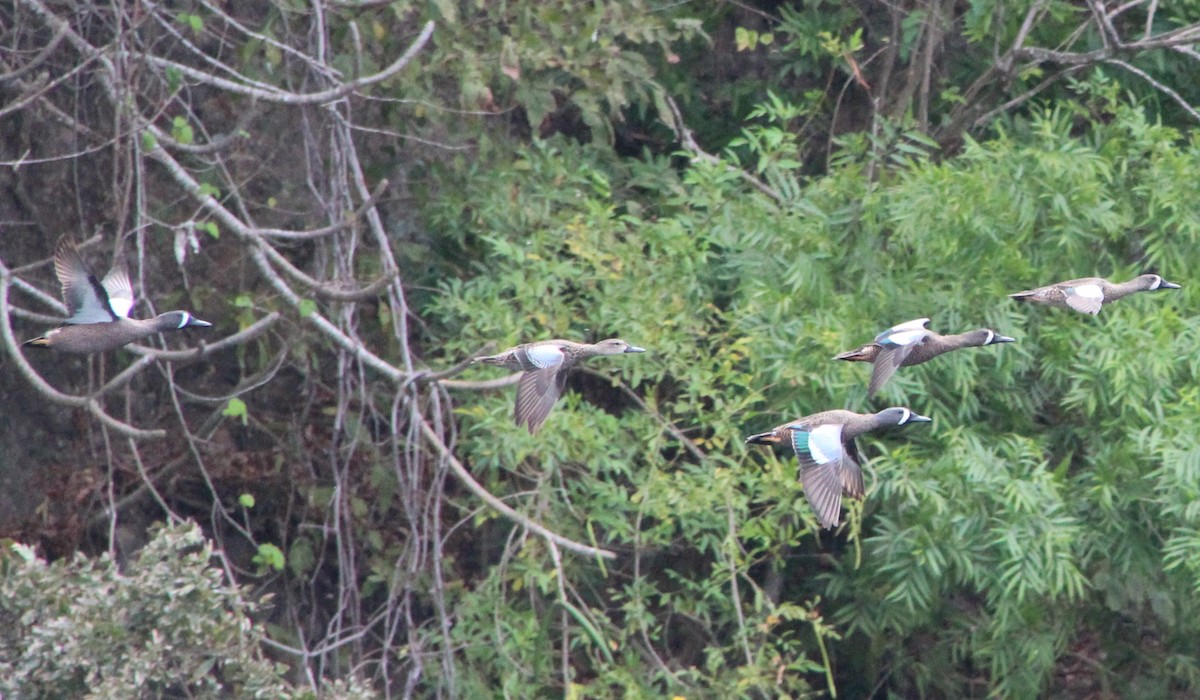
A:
431;86;1200;696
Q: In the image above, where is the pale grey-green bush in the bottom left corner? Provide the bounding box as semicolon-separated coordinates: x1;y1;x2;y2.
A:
0;525;371;700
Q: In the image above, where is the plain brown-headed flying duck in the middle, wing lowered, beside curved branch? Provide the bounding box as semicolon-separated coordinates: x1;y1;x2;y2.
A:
474;337;646;433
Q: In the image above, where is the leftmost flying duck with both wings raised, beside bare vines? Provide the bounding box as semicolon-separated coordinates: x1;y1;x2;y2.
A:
25;240;212;353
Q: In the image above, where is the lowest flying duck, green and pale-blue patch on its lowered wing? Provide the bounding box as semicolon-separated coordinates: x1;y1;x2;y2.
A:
746;407;931;528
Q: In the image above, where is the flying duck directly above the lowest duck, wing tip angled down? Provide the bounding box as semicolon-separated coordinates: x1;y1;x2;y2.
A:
834;318;1014;396
